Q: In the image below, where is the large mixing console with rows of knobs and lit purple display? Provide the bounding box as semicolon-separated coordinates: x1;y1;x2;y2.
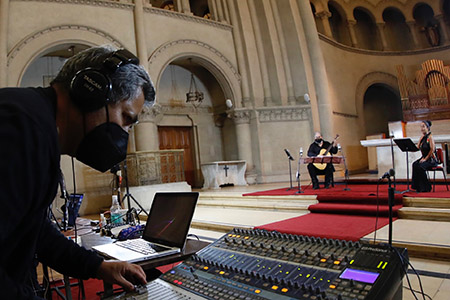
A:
105;229;408;300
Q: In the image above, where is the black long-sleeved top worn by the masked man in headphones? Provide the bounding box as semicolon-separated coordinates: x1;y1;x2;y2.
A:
0;88;102;299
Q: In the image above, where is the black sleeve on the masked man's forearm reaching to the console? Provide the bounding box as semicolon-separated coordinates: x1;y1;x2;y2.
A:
37;219;103;279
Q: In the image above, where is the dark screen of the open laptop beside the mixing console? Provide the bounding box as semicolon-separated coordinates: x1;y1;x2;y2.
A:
142;192;198;249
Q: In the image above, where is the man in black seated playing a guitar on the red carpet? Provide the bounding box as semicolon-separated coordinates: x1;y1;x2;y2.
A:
308;132;338;190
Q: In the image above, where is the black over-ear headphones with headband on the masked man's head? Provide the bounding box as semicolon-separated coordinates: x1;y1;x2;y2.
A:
70;49;139;112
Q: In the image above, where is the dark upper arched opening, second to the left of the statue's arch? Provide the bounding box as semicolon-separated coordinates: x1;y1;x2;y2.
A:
353;7;382;50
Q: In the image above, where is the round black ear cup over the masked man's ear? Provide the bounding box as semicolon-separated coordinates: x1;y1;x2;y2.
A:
70;68;112;112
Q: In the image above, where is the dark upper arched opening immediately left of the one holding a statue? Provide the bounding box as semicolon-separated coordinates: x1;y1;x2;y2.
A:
383;7;413;51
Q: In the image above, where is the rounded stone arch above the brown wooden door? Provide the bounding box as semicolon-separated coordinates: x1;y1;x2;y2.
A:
148;40;242;107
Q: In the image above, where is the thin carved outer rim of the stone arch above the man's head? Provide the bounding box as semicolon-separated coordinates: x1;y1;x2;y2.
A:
8;25;124;65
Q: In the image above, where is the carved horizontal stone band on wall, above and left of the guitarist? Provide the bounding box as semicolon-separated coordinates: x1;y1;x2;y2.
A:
257;105;311;123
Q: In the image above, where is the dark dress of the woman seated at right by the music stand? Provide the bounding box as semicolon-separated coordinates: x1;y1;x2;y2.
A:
411;133;437;193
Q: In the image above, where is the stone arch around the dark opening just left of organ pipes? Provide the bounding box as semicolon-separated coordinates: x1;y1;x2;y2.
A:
355;72;400;139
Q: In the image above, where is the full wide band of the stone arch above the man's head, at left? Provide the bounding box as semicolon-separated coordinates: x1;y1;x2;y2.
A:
8;25;125;86
